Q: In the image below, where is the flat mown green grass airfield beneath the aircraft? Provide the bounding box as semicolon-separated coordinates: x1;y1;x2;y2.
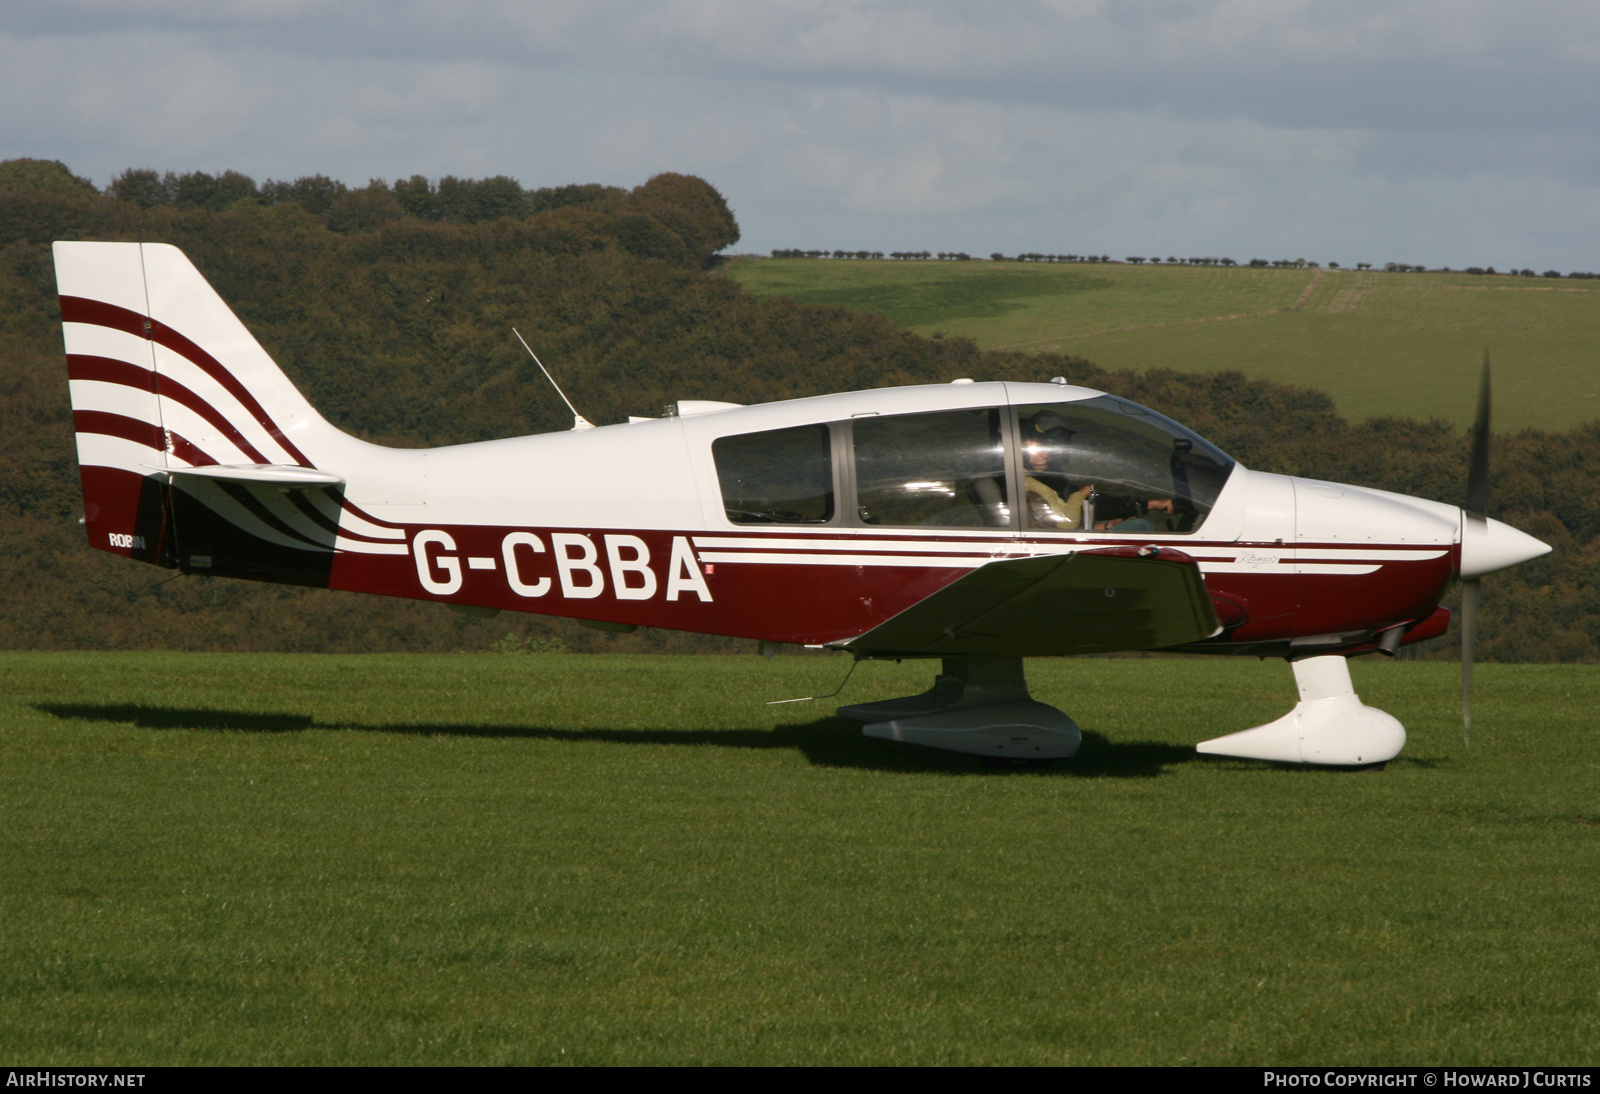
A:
0;653;1600;1065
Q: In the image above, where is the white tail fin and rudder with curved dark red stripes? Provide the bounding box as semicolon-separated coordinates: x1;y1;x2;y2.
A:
54;243;389;585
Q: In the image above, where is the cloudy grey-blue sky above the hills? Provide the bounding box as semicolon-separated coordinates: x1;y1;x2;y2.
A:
0;0;1600;272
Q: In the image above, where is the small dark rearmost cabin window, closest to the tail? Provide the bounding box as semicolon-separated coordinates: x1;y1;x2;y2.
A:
710;425;834;525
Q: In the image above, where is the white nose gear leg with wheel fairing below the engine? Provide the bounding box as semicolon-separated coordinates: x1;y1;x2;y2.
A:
1195;656;1405;768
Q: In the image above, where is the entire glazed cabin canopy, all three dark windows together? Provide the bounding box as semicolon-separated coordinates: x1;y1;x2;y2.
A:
712;395;1234;534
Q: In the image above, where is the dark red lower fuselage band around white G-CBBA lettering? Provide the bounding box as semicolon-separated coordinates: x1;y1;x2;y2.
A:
318;525;1453;645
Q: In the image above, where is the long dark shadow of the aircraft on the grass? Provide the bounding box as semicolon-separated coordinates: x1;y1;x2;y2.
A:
34;702;1198;779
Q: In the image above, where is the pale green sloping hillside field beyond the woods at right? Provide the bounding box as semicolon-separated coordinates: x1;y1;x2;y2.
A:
731;259;1600;430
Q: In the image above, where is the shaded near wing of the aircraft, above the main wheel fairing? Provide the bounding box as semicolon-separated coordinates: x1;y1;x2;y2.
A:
840;547;1218;656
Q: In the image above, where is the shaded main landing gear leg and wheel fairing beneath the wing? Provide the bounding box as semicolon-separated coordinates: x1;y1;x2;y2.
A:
838;657;1083;761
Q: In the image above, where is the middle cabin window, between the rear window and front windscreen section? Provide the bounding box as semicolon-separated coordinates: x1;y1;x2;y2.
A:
851;408;1011;528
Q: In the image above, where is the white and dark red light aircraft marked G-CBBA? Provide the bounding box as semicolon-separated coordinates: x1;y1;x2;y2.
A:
54;243;1550;766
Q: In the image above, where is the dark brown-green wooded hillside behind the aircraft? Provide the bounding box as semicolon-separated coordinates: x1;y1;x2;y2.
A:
0;160;1600;662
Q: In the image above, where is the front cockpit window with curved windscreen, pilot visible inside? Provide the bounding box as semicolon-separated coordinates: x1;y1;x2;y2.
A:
1016;395;1234;534
